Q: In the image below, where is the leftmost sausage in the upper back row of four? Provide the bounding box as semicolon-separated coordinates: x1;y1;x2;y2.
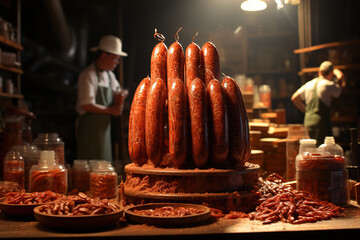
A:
150;42;168;85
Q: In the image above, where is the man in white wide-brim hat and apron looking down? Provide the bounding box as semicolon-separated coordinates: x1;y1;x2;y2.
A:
76;35;127;161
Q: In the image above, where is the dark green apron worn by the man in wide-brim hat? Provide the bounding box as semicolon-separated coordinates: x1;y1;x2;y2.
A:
77;66;113;162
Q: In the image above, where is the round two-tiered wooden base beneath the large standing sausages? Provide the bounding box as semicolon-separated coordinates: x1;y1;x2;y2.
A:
124;163;260;212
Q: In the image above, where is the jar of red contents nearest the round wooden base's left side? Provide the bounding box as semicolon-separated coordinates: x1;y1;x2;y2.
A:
90;161;117;198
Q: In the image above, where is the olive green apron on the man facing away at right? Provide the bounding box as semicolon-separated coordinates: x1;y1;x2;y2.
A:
304;80;332;145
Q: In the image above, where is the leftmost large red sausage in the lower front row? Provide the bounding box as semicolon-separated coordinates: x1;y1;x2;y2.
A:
128;77;150;166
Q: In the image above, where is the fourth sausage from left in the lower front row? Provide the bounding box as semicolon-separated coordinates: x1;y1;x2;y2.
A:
188;78;209;167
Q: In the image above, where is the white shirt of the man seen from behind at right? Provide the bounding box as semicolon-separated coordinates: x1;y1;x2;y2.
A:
297;77;341;107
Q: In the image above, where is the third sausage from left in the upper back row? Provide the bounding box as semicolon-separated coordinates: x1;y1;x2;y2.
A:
185;42;203;90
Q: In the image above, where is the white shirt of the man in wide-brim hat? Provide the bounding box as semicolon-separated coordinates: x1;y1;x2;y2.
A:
76;63;120;115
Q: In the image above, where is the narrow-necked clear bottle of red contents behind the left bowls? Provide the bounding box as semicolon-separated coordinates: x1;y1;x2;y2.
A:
29;151;68;194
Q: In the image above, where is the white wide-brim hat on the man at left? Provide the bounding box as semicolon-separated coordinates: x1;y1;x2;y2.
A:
90;35;127;57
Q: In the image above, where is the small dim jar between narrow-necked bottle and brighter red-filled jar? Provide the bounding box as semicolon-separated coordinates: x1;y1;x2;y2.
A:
71;160;90;192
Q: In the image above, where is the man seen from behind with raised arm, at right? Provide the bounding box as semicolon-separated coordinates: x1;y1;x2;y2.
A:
291;61;345;145
